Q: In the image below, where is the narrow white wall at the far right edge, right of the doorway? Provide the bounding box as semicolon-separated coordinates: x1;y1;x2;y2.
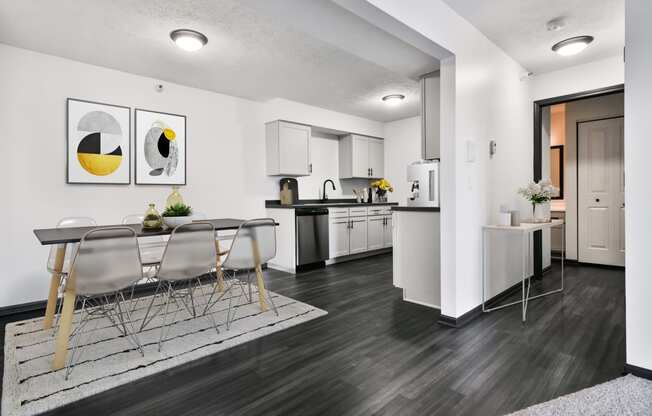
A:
625;0;652;370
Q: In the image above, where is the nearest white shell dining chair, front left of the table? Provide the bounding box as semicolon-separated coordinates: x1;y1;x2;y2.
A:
65;226;144;380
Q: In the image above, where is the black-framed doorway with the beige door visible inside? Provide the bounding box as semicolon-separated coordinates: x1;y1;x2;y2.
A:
533;84;624;276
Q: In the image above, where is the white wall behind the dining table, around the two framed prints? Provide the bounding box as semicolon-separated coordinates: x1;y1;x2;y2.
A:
0;44;383;306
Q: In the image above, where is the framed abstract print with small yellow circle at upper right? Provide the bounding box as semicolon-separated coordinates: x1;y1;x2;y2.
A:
136;108;186;185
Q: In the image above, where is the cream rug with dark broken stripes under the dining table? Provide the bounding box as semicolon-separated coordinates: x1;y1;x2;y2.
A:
2;282;327;416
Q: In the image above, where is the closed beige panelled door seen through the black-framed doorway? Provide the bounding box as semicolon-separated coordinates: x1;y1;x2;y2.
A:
577;117;625;266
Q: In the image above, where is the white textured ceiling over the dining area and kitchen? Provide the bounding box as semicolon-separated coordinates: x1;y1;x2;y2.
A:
0;0;438;121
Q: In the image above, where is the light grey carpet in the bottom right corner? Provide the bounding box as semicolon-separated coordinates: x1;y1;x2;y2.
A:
511;375;652;416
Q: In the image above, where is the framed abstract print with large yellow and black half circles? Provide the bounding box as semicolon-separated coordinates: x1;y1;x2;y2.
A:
66;98;131;185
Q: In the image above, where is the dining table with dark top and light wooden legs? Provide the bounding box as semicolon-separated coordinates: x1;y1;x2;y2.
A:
34;218;278;370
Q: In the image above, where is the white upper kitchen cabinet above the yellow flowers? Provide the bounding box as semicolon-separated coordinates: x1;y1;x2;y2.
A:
340;134;385;179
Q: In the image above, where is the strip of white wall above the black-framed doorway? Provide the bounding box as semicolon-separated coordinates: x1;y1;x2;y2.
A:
532;55;625;101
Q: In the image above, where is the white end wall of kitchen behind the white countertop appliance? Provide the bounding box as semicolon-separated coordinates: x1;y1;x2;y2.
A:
383;117;421;205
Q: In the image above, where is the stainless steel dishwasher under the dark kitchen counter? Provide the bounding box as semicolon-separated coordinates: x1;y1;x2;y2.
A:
295;207;328;267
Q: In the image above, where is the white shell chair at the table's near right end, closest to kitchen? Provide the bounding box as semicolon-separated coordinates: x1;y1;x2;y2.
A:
204;218;278;330
